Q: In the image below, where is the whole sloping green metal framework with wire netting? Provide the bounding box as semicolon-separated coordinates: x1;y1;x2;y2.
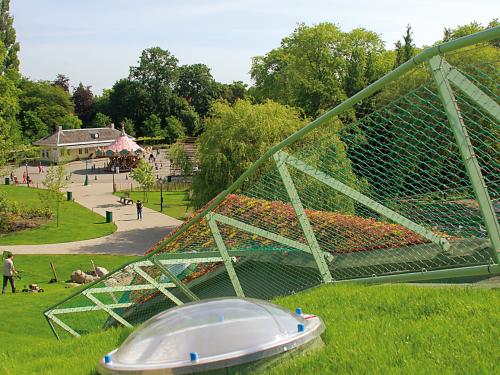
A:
45;27;500;338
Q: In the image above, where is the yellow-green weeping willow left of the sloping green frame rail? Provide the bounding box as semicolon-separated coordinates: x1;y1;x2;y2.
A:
193;100;305;207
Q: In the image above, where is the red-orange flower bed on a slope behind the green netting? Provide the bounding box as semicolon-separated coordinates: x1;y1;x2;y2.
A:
146;194;434;254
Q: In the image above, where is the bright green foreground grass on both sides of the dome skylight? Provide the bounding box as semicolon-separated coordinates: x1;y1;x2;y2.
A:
0;255;500;375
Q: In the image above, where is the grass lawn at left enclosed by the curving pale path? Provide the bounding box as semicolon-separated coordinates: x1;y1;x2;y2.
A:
0;185;116;245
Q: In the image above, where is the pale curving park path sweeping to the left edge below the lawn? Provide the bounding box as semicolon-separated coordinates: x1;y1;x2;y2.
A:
0;182;182;255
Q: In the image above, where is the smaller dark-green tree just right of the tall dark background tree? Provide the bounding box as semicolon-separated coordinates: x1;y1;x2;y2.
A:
176;64;218;117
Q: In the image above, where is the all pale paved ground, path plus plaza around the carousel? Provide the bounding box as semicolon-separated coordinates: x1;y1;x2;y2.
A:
0;153;182;255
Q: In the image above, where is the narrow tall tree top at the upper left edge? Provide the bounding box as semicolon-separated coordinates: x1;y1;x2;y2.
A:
0;0;19;78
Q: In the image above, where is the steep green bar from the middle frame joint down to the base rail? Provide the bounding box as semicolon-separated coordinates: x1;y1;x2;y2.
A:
273;151;333;283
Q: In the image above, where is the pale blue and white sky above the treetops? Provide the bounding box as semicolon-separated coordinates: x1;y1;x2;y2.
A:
11;0;500;94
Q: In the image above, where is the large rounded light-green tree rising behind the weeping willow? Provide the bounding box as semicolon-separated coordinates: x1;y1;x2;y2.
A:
250;23;384;117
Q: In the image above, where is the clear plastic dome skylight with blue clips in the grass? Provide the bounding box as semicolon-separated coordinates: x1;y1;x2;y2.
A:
99;298;324;374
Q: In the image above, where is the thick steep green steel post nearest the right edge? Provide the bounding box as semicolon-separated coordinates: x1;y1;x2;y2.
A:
429;56;500;264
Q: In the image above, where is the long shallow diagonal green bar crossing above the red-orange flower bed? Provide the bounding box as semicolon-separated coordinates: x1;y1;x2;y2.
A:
280;151;450;251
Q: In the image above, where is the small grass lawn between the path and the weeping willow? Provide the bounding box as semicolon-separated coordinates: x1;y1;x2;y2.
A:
115;191;192;220
